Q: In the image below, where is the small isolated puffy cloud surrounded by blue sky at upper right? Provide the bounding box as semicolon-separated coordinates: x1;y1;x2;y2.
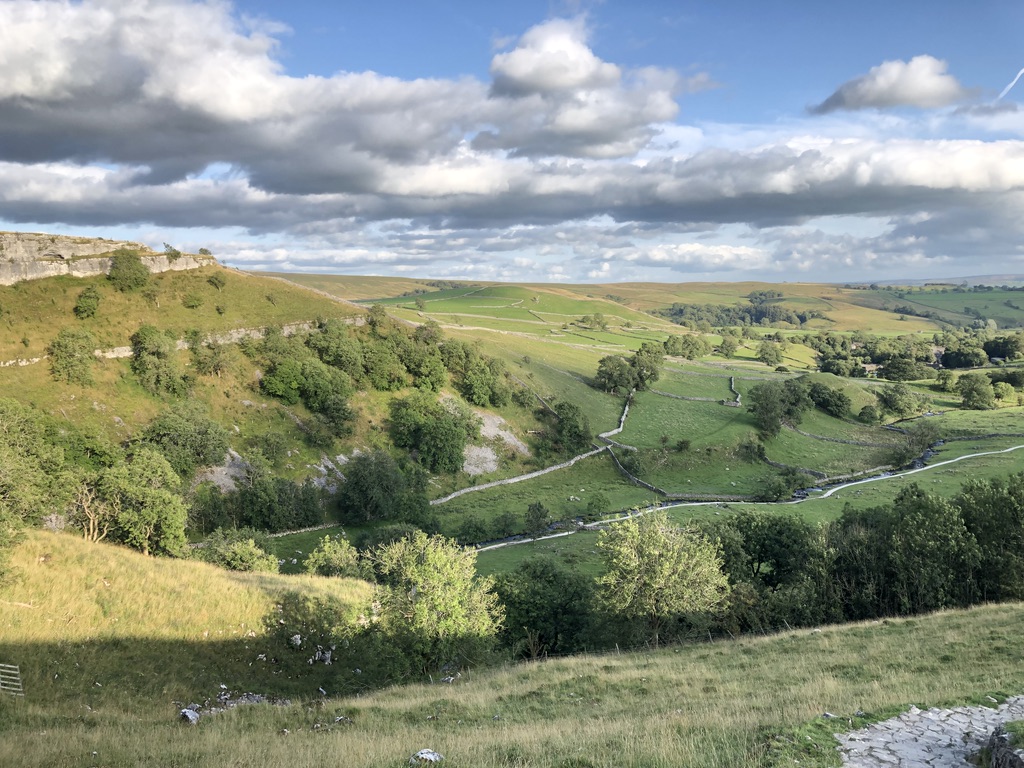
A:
811;55;968;115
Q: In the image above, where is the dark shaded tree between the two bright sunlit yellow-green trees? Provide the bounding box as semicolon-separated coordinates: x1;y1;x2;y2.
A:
495;556;596;658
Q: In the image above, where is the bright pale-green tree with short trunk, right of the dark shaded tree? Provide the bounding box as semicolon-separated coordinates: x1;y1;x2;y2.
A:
597;512;729;646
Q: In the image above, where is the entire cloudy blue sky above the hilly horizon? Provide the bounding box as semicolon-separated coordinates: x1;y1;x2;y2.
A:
0;0;1024;283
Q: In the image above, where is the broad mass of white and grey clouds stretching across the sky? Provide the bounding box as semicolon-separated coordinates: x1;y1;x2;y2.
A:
0;0;1024;281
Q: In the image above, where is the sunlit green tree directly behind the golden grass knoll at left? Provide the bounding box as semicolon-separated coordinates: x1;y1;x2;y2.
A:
98;447;188;555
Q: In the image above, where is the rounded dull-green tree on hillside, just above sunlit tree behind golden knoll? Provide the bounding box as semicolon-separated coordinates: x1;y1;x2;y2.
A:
142;400;228;478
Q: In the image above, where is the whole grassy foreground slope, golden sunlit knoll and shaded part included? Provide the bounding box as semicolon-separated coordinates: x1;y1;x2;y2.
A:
0;534;1024;768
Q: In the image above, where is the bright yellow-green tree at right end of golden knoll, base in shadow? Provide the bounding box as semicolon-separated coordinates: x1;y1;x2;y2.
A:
371;530;504;676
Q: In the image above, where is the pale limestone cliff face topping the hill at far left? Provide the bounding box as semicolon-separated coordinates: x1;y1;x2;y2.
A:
0;232;213;286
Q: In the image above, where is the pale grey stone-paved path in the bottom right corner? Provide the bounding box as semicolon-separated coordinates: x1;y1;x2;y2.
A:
836;696;1024;768
